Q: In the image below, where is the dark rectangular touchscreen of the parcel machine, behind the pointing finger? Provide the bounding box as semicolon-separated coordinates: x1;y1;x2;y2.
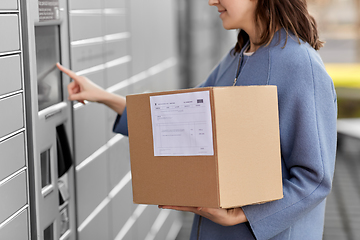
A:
35;25;63;111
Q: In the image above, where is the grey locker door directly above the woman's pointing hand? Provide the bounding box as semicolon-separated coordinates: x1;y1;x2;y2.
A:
71;42;104;71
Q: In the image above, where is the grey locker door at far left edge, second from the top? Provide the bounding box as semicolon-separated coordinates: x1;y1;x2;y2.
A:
0;15;20;52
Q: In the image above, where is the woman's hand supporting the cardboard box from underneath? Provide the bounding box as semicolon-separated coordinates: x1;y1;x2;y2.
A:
159;205;247;226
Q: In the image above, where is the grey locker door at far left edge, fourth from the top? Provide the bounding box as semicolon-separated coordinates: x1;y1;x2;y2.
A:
0;94;24;138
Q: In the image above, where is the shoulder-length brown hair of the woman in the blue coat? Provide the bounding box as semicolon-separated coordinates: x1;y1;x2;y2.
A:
234;0;324;53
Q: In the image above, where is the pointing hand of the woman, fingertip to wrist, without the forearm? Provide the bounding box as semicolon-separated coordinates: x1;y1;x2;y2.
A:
56;63;107;103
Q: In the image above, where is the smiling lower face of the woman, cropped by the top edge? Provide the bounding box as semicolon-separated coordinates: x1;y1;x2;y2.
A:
209;0;257;31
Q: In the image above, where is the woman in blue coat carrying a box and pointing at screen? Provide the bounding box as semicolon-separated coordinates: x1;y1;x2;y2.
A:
59;0;337;237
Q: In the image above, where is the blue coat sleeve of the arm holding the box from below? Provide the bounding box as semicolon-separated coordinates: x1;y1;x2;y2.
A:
242;47;337;240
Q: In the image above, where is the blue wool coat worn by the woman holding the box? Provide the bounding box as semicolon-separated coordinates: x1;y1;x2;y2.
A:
114;30;337;240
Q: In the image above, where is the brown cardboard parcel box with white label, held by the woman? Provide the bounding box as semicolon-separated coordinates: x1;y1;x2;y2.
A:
126;86;283;208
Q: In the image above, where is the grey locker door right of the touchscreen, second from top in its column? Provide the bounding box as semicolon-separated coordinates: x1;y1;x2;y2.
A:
70;14;102;41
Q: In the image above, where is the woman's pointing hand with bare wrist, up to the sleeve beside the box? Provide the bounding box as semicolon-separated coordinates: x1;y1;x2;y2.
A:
56;63;126;114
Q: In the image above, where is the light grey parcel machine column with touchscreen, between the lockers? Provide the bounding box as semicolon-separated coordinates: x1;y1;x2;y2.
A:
22;0;76;240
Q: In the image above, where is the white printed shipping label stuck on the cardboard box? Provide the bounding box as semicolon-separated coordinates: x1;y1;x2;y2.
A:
150;91;214;156
